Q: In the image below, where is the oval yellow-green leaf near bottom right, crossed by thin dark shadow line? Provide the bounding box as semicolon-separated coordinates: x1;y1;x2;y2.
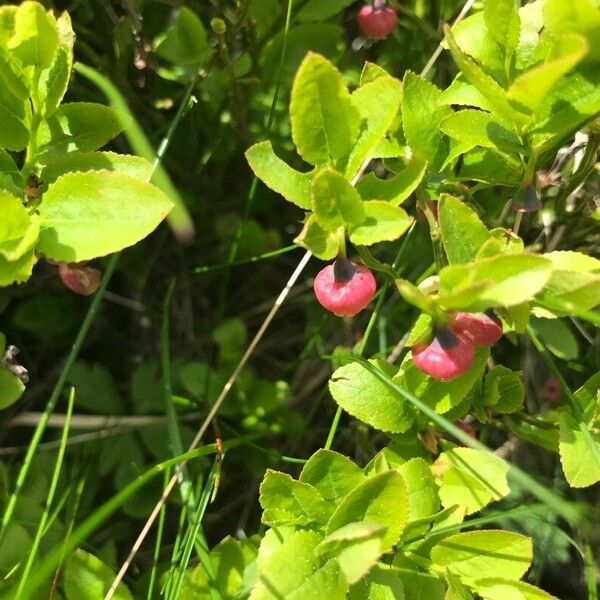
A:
431;529;533;580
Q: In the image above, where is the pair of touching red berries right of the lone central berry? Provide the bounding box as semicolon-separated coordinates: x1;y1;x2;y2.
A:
412;312;502;381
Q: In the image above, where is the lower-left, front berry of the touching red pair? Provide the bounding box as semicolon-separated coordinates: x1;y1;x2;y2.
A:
412;327;475;381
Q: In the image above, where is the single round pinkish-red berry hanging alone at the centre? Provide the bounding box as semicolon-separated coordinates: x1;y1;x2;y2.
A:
313;258;377;317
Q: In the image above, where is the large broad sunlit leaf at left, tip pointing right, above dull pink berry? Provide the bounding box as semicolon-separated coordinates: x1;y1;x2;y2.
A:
38;171;172;262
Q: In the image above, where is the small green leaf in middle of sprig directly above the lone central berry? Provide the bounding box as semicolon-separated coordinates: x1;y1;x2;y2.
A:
310;168;366;231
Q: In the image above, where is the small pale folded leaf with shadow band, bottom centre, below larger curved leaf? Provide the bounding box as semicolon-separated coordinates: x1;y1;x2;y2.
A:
316;522;386;584
